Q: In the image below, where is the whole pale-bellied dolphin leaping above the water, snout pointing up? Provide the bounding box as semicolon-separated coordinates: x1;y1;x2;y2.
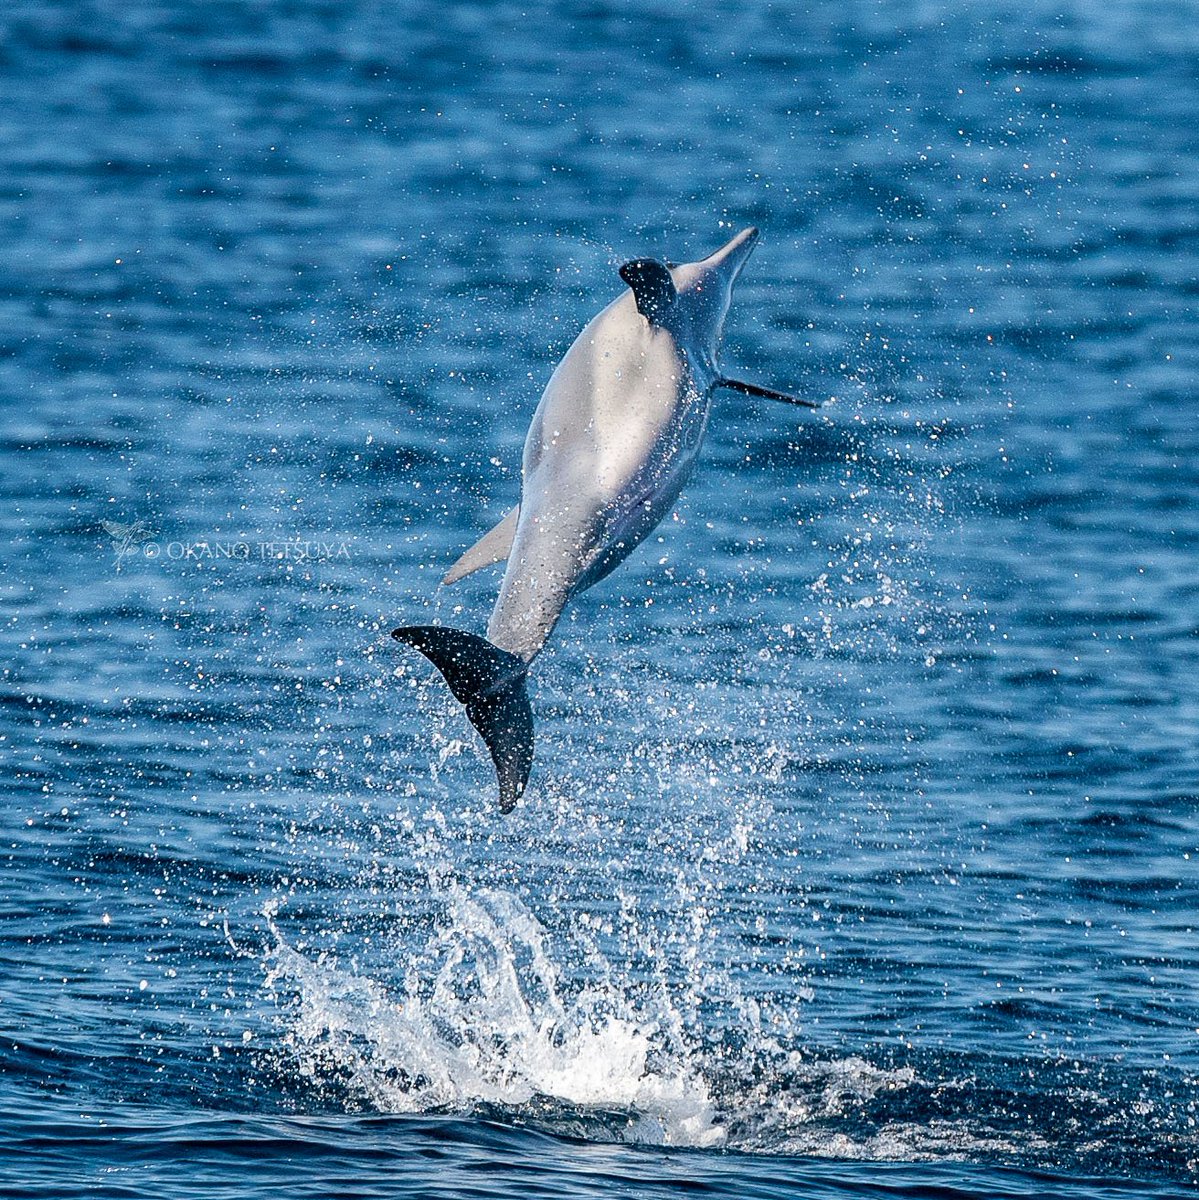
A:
391;227;820;812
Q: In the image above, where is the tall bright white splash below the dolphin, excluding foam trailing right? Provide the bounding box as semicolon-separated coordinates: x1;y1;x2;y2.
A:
268;884;724;1146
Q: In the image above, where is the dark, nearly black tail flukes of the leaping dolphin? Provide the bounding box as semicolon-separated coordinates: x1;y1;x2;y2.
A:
391;625;533;812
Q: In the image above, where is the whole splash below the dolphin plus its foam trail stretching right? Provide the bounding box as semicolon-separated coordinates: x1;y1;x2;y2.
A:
266;884;1044;1160
